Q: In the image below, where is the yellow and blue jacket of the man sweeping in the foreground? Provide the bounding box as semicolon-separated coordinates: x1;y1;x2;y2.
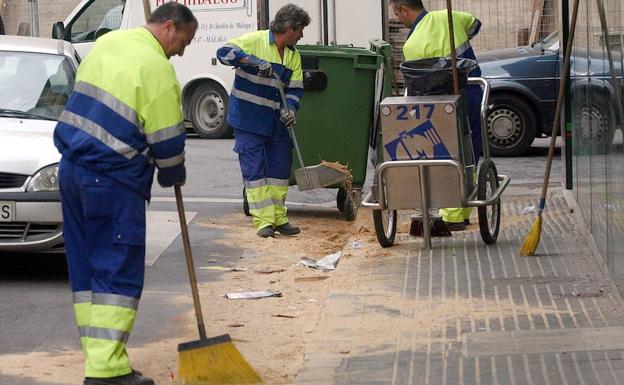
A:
54;27;186;199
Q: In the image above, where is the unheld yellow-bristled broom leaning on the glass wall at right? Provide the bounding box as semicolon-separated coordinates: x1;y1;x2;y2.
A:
520;0;579;257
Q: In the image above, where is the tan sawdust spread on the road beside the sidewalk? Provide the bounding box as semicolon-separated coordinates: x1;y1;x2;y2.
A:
191;208;374;384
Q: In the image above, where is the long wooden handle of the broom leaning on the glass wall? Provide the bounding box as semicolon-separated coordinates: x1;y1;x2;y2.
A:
539;0;579;210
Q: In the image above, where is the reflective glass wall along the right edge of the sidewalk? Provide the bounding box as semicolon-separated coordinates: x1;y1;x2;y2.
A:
569;0;624;292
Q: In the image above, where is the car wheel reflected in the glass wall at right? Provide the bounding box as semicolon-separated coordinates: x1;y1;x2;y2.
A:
574;95;615;150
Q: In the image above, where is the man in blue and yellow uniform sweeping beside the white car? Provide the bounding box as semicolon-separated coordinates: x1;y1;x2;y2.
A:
54;2;197;385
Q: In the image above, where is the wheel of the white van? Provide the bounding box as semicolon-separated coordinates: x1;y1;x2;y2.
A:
190;83;232;139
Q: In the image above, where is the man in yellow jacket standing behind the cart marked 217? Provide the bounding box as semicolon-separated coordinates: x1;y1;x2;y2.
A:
390;0;483;231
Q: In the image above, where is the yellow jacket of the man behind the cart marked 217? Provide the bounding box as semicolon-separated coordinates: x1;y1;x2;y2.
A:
403;9;481;76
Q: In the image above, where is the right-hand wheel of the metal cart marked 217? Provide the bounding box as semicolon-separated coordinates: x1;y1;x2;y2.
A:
477;159;500;245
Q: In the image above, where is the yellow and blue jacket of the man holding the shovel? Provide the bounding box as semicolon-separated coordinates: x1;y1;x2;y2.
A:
217;30;303;136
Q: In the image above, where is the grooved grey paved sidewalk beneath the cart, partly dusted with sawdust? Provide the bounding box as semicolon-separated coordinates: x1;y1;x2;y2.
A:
296;189;624;385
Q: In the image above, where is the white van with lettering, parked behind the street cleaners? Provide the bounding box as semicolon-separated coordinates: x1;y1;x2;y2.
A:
52;0;386;138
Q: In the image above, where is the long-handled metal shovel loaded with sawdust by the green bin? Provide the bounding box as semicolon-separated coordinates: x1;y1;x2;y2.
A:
275;74;352;191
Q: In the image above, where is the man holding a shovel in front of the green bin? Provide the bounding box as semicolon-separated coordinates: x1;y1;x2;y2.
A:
217;4;310;238
